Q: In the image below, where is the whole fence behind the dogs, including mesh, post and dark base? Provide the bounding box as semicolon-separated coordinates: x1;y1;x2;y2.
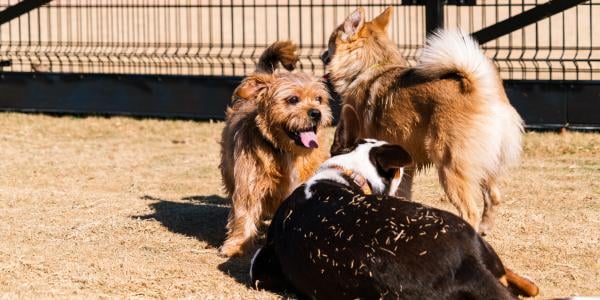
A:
0;0;600;128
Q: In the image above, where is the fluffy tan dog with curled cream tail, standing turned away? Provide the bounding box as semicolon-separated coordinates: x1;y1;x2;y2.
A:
321;8;523;233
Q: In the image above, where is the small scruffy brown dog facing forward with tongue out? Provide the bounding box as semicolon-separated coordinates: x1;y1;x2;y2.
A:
220;41;332;256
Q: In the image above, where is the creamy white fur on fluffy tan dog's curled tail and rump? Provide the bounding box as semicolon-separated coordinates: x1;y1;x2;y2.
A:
415;29;523;178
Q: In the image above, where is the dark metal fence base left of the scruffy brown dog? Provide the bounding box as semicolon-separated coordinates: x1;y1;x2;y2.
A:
0;72;241;119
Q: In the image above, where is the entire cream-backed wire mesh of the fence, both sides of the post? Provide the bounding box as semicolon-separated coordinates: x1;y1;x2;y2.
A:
0;0;600;80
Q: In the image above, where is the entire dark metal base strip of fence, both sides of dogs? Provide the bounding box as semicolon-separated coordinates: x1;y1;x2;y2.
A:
0;72;600;129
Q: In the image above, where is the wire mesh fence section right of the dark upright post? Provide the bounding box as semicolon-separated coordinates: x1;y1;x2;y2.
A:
445;0;600;80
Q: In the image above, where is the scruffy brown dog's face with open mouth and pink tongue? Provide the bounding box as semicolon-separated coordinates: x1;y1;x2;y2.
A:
236;73;332;151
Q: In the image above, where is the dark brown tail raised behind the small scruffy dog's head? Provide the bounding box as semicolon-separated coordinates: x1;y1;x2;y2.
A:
256;41;298;74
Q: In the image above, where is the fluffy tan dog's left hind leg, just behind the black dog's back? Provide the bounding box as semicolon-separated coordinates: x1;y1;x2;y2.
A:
438;162;479;229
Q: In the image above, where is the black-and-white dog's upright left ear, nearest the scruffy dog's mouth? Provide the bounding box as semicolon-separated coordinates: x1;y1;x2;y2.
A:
329;104;360;156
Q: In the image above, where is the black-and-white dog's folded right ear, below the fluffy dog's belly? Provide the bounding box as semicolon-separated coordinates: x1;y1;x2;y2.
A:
369;144;412;179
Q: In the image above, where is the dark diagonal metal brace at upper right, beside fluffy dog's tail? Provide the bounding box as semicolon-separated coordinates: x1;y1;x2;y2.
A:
472;0;588;44
